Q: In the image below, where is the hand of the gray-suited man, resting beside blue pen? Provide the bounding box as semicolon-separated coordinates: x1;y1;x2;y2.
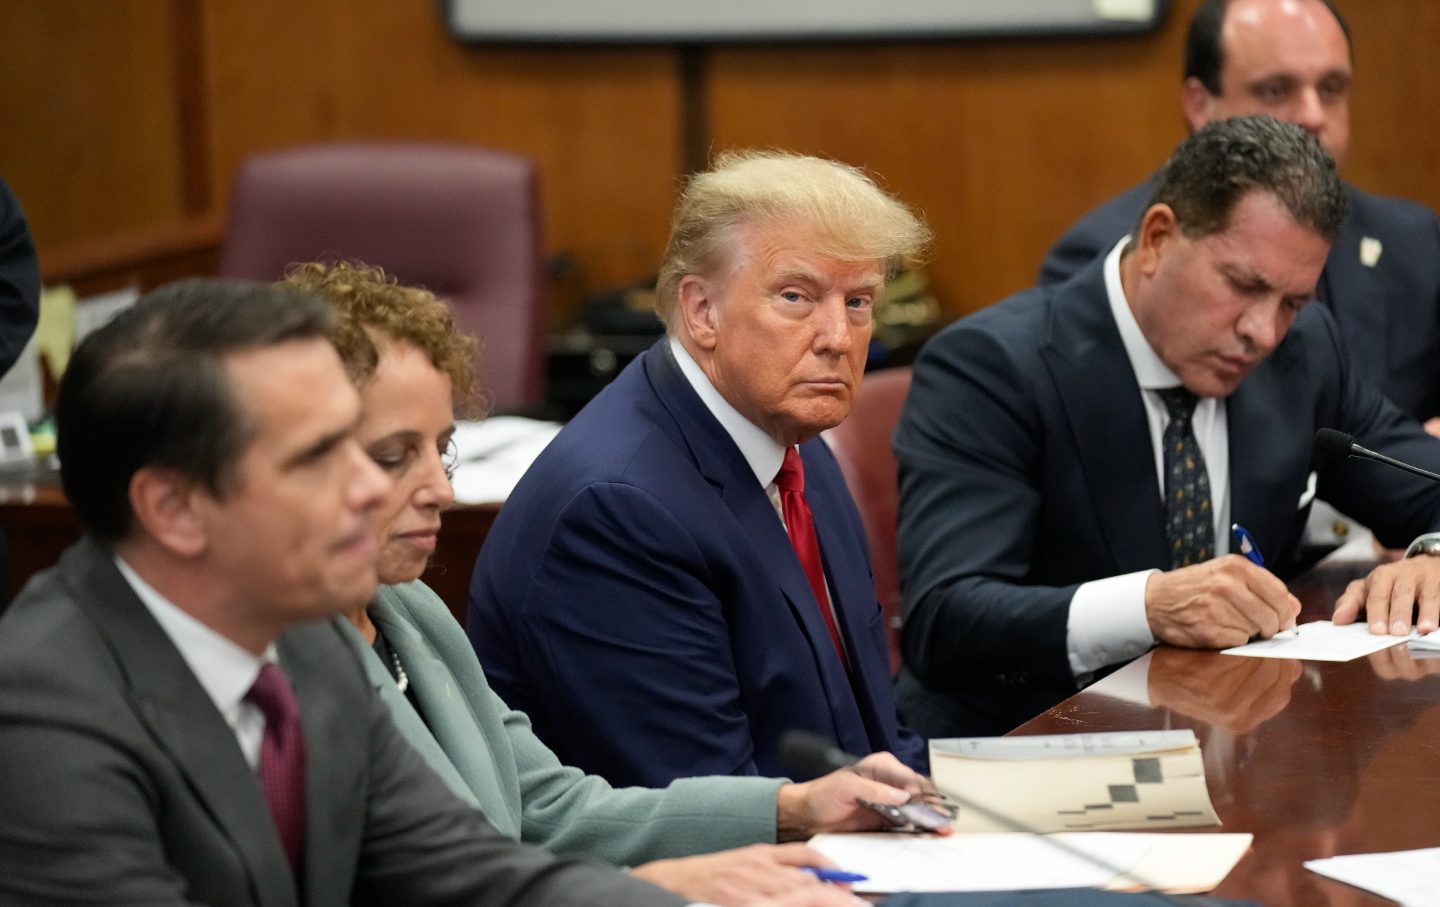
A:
631;844;852;907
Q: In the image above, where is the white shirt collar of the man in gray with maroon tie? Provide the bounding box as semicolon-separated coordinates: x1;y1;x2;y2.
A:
115;554;275;714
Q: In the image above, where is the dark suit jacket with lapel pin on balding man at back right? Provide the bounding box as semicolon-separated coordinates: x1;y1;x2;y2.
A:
1040;177;1440;419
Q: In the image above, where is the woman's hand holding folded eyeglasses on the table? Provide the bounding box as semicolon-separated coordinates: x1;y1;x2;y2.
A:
775;753;949;841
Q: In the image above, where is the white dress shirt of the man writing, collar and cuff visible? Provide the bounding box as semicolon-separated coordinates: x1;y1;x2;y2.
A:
1066;236;1230;682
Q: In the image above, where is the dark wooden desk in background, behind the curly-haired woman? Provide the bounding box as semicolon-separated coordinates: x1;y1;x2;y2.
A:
0;474;500;623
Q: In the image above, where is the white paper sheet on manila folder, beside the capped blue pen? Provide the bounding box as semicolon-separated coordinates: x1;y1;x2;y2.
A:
809;834;1149;894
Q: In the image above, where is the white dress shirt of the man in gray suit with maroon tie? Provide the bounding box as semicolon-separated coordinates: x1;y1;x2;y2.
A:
115;556;275;769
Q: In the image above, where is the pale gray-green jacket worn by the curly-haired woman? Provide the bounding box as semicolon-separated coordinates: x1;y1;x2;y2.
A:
346;582;782;865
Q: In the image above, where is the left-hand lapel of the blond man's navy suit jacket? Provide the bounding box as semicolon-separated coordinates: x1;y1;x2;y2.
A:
647;340;870;752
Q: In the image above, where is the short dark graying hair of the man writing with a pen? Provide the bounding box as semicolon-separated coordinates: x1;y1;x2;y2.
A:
1135;115;1346;242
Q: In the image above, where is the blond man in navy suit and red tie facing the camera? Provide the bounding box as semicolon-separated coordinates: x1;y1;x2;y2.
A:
468;153;929;786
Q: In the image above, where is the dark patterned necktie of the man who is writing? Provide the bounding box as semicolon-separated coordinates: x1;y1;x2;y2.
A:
1156;387;1215;570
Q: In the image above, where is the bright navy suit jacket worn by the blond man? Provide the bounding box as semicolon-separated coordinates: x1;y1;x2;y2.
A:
468;340;924;786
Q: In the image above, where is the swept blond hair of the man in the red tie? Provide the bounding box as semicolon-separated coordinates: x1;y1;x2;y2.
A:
655;150;932;330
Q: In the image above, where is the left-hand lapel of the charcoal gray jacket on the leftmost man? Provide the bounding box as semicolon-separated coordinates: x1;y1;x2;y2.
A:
62;538;297;907
